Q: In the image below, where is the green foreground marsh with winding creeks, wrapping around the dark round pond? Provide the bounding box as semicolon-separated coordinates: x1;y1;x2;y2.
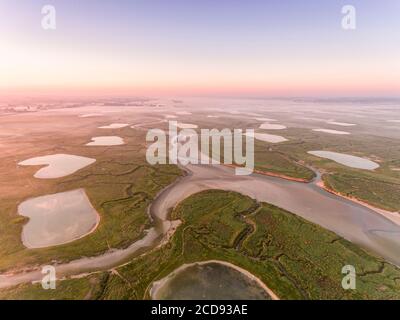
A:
0;190;400;299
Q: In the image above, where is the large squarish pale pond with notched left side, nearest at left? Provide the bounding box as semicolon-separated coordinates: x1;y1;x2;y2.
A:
18;189;100;248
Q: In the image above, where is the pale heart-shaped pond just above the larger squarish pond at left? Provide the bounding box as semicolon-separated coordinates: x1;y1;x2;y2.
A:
18;154;96;179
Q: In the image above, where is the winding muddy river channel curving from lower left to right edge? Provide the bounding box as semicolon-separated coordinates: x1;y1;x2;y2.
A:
0;165;400;288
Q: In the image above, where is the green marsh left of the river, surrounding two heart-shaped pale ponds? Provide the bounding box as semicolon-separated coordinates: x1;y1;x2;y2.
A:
0;128;182;272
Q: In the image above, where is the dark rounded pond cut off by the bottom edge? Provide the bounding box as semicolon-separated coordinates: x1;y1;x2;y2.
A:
151;262;271;300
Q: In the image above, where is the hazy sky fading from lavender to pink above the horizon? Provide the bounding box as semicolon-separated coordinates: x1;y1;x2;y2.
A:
0;0;400;97
